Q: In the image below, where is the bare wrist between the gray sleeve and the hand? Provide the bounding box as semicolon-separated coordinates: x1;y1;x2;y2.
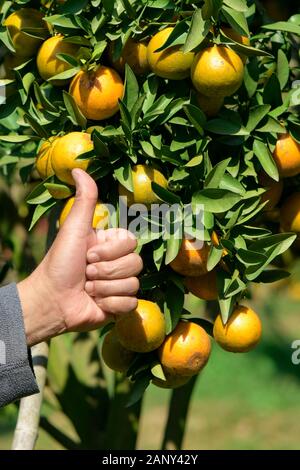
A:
17;271;65;347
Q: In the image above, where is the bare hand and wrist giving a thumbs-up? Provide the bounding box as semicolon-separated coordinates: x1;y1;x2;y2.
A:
18;169;142;346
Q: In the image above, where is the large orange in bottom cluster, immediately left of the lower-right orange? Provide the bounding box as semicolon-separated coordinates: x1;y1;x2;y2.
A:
158;321;211;377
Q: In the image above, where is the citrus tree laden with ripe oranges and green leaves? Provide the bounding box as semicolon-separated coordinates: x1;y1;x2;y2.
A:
0;0;300;448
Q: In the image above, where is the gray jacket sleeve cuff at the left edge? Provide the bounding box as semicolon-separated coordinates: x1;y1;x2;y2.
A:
0;284;39;407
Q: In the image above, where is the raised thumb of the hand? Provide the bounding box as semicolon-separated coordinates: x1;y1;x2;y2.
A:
62;168;98;235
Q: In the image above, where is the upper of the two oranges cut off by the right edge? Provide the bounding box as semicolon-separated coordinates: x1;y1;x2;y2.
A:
273;133;300;177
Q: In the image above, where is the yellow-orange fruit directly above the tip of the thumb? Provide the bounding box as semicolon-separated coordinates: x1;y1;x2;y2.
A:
52;132;94;186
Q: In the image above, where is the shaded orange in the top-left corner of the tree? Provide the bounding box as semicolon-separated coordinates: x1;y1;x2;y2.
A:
4;8;49;58
